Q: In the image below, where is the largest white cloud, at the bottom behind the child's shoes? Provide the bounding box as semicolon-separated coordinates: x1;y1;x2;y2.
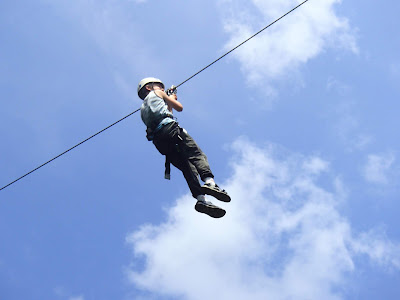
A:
127;139;400;300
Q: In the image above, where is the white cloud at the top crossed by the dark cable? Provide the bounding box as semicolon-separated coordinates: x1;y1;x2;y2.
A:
220;0;358;89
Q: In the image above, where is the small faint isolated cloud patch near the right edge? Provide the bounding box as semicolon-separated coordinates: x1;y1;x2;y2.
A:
363;153;395;184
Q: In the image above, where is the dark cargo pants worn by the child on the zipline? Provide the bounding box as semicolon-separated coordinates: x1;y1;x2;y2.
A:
153;122;214;198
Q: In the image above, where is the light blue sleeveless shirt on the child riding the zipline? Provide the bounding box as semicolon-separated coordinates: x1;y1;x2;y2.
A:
140;91;174;130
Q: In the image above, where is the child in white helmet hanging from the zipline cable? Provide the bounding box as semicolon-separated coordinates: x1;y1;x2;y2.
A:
137;77;231;218
